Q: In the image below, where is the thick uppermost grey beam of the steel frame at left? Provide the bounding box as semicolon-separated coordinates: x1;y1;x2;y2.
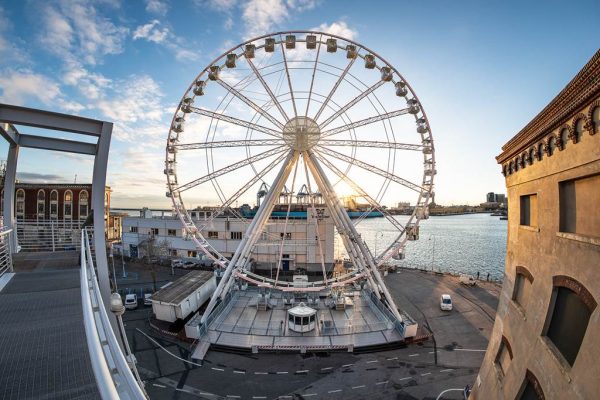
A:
0;103;103;136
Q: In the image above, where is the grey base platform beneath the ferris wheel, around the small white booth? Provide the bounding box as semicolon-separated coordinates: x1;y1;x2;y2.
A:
192;290;417;360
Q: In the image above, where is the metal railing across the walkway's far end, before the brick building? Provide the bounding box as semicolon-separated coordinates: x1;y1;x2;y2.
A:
16;219;83;252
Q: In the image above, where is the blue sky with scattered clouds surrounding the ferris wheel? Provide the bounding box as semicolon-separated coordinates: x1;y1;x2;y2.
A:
0;0;600;208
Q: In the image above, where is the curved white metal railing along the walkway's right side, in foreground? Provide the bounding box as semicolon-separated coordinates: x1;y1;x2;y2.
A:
80;229;146;400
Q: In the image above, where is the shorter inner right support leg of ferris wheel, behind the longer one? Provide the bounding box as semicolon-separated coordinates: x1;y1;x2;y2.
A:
304;155;381;298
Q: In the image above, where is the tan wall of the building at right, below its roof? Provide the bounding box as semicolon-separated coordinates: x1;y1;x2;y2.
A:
470;87;600;400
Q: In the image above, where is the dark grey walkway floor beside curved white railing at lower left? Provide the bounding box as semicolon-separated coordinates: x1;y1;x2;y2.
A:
0;266;99;400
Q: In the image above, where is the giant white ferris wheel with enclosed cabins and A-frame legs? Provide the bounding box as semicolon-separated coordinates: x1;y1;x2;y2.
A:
165;31;436;322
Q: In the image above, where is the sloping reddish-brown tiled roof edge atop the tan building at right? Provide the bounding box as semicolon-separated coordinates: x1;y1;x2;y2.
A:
496;50;600;164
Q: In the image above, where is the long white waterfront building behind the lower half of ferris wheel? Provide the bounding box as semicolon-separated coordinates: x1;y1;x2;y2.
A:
122;208;335;271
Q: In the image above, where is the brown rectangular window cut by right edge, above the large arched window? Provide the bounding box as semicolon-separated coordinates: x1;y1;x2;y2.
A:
558;174;600;237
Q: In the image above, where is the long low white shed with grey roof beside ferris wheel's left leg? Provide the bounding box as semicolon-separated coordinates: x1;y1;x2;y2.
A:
152;271;217;322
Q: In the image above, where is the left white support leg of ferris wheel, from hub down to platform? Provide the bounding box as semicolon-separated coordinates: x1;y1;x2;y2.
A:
201;151;298;323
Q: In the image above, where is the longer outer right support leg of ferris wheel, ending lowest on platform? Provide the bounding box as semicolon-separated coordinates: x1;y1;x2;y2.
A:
308;152;402;321
